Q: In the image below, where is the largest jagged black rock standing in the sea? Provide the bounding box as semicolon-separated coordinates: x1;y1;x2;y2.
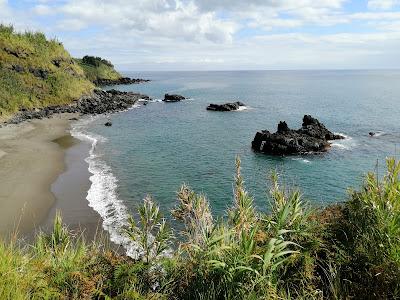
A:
252;115;344;155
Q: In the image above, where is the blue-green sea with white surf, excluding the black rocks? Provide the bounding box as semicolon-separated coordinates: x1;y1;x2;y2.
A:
74;71;400;251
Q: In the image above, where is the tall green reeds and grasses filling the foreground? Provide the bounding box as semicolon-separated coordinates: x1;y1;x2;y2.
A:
0;159;400;299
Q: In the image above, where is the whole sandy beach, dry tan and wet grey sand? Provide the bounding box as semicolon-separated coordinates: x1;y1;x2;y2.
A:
0;114;101;236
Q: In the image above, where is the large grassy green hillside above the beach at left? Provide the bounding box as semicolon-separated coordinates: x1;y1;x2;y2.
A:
0;25;94;117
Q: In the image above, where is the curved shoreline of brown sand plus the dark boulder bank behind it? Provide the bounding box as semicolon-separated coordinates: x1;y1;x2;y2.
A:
0;90;149;239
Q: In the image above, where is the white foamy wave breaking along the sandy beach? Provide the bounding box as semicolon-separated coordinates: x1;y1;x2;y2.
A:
71;117;139;258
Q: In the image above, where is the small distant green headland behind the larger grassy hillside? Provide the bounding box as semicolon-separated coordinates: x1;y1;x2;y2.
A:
76;56;122;82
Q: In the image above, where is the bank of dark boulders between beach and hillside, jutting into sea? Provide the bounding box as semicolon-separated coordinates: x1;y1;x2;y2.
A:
6;90;150;124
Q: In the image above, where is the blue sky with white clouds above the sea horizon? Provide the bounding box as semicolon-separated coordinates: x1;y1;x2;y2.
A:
0;0;400;71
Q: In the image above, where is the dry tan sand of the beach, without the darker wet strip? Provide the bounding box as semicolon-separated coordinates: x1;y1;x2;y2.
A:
0;114;94;236
